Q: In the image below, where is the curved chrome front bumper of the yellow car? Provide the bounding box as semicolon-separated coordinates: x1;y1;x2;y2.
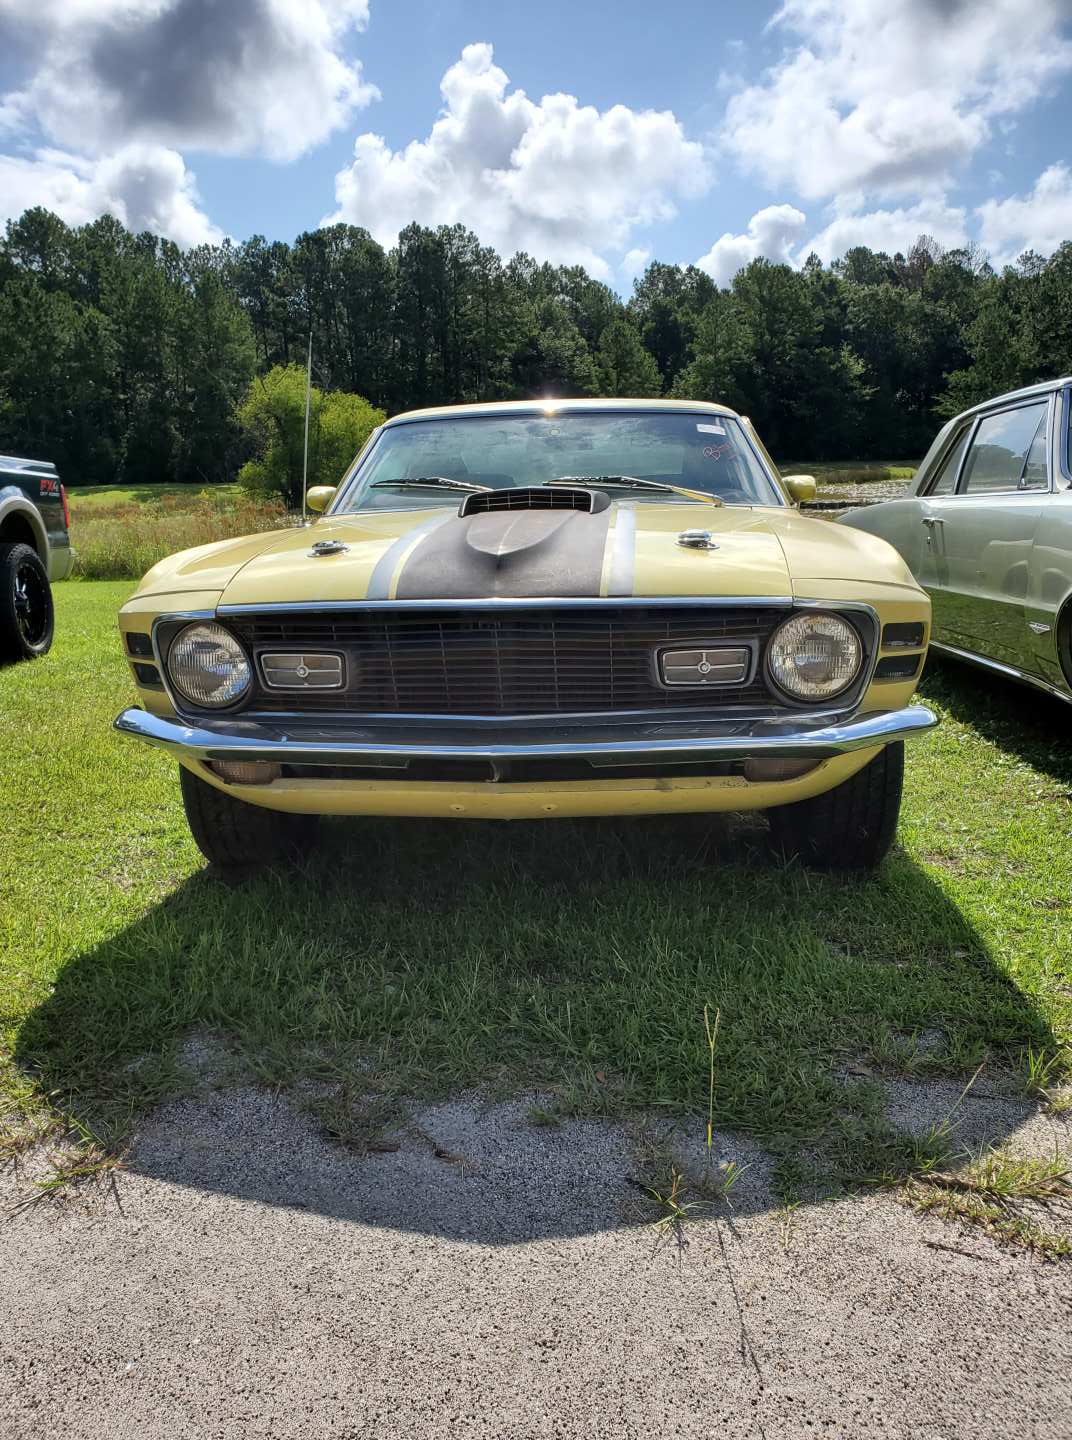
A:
115;706;938;769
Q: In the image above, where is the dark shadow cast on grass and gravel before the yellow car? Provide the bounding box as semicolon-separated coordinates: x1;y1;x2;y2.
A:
16;816;1055;1243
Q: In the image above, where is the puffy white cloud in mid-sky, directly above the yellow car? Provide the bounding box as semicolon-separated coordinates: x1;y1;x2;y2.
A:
329;45;709;278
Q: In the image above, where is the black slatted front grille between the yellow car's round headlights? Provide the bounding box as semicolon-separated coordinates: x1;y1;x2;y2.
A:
222;602;790;716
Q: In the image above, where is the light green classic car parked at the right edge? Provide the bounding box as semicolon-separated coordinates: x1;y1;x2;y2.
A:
839;379;1072;701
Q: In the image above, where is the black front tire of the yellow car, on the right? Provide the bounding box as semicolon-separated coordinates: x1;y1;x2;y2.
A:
768;740;905;870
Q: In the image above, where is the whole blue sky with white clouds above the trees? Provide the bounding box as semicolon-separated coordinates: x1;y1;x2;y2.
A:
0;0;1072;291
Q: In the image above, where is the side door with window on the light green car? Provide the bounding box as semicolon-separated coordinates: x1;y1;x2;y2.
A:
919;396;1053;665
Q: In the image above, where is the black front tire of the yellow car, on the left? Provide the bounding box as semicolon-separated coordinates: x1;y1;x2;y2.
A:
179;765;318;870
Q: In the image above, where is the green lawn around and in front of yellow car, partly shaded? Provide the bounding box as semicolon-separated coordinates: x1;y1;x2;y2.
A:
0;582;1072;1194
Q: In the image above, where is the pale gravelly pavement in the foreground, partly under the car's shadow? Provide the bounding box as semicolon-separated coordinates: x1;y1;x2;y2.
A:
0;1086;1072;1440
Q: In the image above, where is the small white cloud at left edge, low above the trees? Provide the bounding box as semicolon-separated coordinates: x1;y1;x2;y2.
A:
0;144;223;249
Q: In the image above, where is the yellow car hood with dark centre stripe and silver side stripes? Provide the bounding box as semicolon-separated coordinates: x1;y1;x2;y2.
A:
136;500;915;605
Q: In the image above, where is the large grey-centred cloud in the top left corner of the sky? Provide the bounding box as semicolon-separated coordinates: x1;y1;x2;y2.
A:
0;0;376;160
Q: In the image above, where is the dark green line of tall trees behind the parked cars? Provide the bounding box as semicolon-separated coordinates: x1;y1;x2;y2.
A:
0;209;1072;495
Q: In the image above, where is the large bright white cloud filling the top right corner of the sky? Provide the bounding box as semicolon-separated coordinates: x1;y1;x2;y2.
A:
722;0;1072;199
